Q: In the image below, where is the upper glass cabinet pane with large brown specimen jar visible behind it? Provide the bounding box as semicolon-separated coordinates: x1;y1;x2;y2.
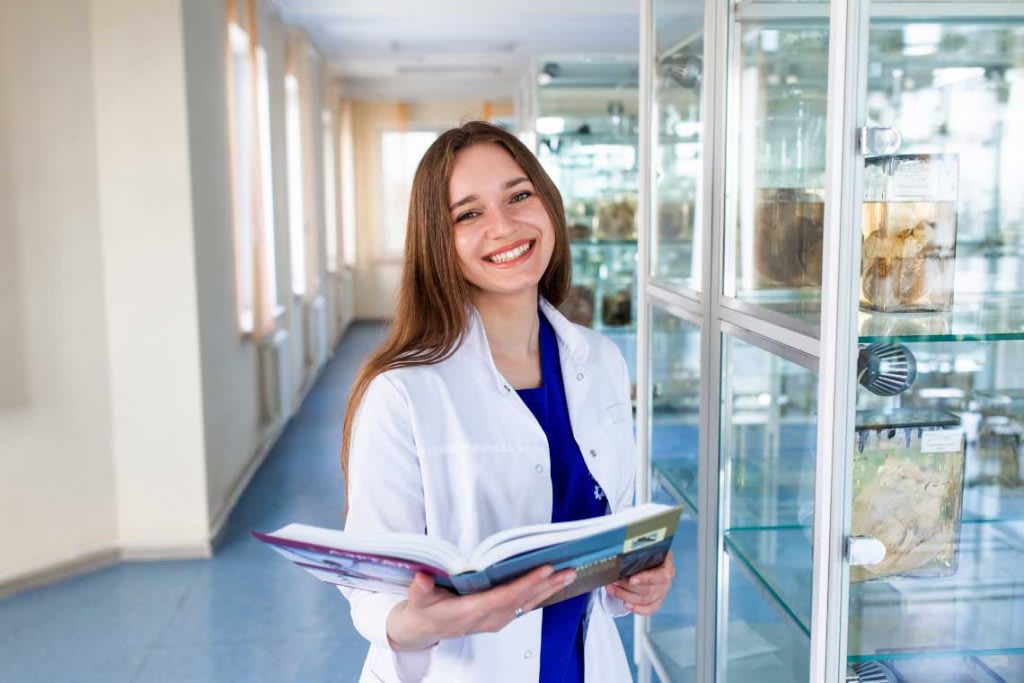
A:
724;25;828;323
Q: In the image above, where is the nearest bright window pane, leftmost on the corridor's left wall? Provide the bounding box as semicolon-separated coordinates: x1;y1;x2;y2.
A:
228;24;254;333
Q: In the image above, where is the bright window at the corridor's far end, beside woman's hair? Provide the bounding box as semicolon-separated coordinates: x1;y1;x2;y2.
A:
378;131;437;256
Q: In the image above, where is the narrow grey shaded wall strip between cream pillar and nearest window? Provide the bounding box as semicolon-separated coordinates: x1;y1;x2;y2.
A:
182;0;261;525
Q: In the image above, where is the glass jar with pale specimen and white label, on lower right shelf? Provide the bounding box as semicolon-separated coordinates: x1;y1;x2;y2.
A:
850;410;965;582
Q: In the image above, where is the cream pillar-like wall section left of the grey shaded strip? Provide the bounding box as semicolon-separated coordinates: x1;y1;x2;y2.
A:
91;0;210;556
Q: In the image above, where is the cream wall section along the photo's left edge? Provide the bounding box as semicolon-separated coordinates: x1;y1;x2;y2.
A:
0;0;117;581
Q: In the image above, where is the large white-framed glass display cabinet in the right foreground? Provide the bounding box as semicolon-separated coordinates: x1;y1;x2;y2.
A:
635;0;1024;683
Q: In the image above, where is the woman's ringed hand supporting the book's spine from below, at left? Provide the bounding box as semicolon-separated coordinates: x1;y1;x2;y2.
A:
387;565;575;650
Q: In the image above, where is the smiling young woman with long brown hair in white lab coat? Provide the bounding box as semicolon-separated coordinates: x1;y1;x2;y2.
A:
342;122;674;683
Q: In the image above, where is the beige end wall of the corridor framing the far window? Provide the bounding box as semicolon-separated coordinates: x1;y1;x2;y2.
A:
352;100;513;318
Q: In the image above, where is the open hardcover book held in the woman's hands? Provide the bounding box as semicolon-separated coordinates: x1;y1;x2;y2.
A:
253;503;683;604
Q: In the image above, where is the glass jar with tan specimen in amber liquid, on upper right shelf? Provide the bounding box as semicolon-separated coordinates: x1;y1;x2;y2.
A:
860;155;958;312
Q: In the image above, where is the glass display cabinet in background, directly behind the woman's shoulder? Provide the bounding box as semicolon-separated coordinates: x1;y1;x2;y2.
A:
534;55;639;378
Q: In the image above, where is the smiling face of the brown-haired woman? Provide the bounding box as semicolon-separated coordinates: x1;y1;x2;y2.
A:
449;143;555;294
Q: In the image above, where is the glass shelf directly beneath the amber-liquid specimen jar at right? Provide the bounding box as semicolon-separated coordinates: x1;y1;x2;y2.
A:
858;296;1024;343
